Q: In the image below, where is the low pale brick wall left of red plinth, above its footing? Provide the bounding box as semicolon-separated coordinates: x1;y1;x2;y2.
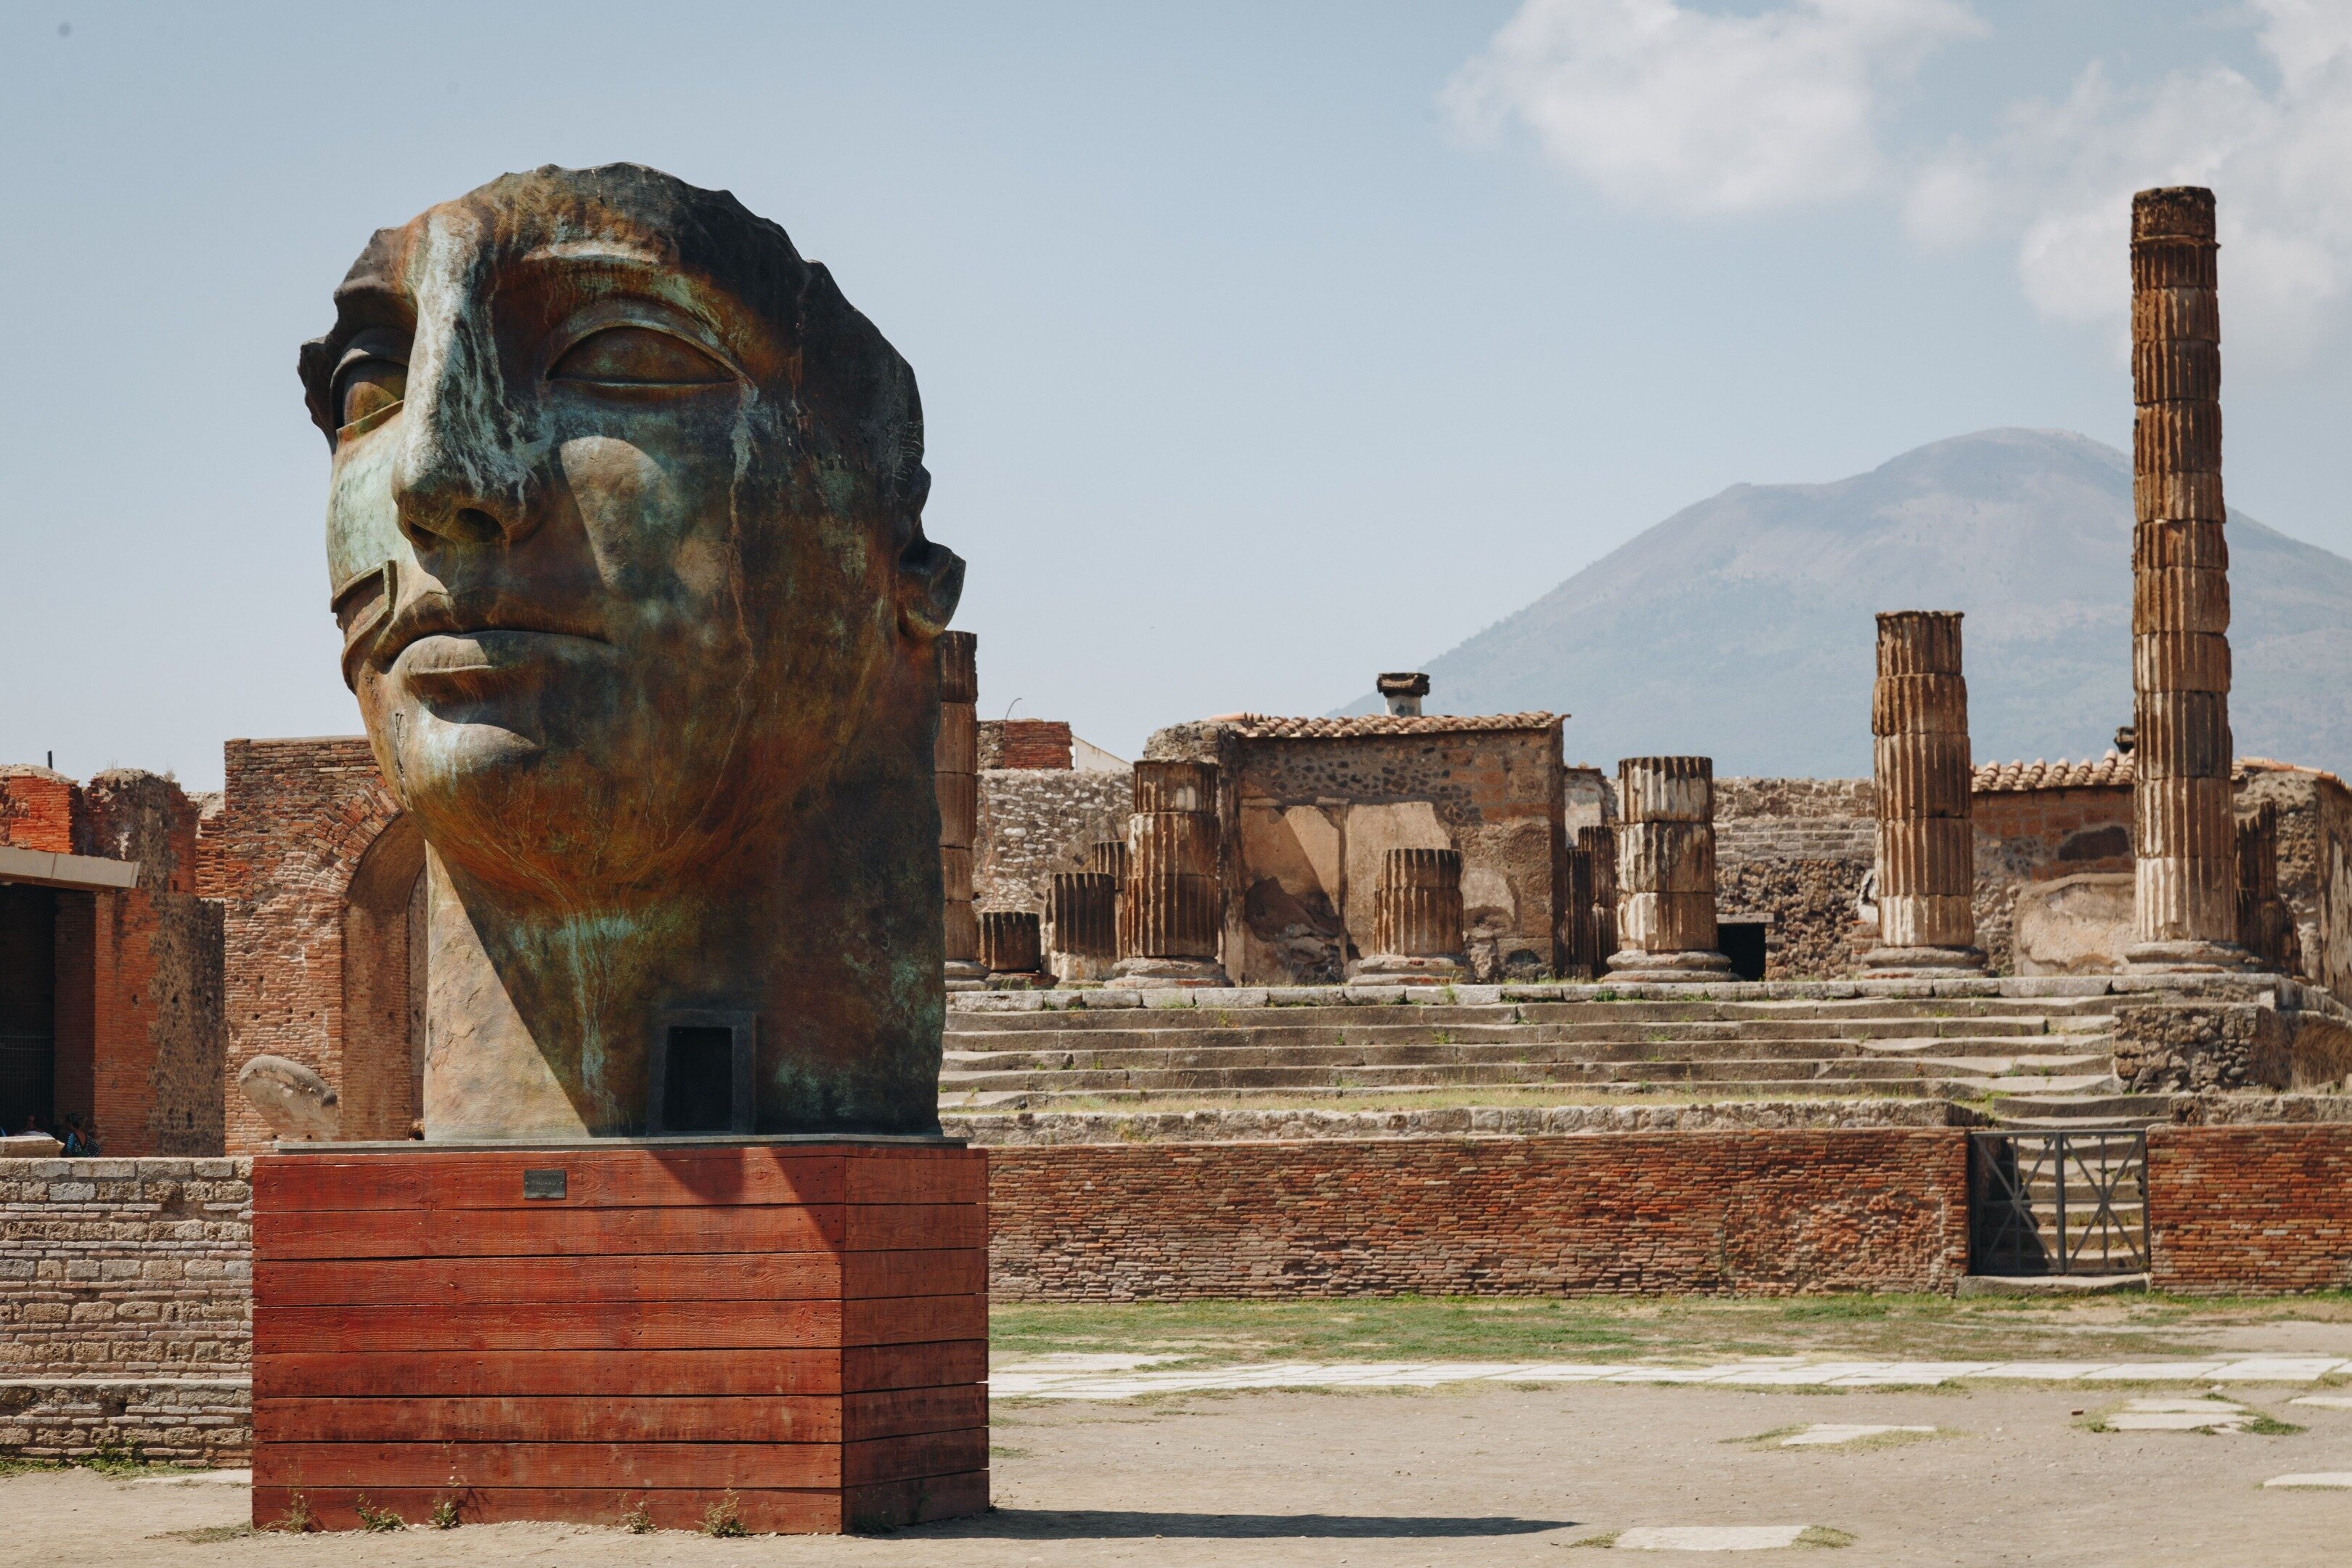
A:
0;1159;252;1380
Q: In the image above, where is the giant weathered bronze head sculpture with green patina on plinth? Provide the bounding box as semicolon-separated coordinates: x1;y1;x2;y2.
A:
301;165;962;1138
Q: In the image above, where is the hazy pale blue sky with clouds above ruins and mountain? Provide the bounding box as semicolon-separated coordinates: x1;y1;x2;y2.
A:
0;0;2352;788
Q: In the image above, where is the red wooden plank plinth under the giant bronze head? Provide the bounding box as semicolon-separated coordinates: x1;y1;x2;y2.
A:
254;1143;988;1530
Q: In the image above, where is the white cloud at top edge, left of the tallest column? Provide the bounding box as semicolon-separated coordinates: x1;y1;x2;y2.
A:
1444;0;1976;214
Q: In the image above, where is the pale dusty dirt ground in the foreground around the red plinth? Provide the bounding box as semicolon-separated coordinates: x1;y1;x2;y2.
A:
18;1384;2352;1568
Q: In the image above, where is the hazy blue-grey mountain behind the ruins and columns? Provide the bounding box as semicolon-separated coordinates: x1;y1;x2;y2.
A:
1343;430;2352;776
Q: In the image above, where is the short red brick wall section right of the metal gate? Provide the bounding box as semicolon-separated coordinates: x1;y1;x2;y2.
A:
2147;1124;2352;1295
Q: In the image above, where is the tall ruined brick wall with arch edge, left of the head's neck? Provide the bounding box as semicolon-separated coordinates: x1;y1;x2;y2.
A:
207;736;404;1154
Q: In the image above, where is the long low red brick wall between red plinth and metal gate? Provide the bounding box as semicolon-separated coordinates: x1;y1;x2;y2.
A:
988;1128;1969;1300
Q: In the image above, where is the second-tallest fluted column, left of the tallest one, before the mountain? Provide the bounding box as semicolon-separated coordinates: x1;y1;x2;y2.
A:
1863;609;1985;978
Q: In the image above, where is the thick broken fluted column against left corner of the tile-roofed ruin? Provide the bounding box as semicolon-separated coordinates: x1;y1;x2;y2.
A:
1113;761;1228;987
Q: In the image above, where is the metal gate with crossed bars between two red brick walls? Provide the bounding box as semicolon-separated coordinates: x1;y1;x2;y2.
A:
1969;1131;2147;1274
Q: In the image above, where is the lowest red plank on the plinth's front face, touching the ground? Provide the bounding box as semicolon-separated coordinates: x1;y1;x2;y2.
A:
254;1483;846;1535
